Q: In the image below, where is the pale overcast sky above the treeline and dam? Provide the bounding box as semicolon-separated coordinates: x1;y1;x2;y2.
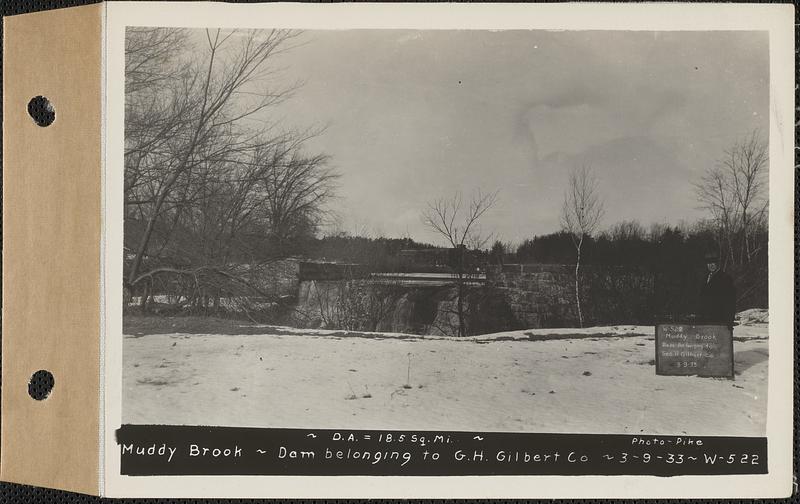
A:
250;30;769;243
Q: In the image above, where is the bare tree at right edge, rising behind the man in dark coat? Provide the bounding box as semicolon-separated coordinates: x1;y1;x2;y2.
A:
695;131;769;267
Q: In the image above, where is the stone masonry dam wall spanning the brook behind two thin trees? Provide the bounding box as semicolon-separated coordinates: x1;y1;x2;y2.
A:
282;261;654;334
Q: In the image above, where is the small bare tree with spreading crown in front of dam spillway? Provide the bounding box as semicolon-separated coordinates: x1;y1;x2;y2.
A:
422;190;497;336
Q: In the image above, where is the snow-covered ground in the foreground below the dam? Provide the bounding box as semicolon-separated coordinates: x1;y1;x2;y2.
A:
122;323;768;436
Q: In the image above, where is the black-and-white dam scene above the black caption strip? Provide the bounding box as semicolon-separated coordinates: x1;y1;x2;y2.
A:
118;26;770;437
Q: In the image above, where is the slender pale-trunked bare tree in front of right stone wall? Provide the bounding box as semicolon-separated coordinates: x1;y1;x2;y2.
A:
561;166;604;327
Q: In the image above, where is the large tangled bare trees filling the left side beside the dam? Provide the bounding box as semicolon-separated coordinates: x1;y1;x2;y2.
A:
124;28;336;314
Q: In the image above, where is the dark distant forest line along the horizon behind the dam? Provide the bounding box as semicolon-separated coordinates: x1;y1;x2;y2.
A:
294;221;768;309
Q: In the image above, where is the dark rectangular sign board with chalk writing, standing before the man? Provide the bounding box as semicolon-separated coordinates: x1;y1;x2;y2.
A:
656;324;733;378
